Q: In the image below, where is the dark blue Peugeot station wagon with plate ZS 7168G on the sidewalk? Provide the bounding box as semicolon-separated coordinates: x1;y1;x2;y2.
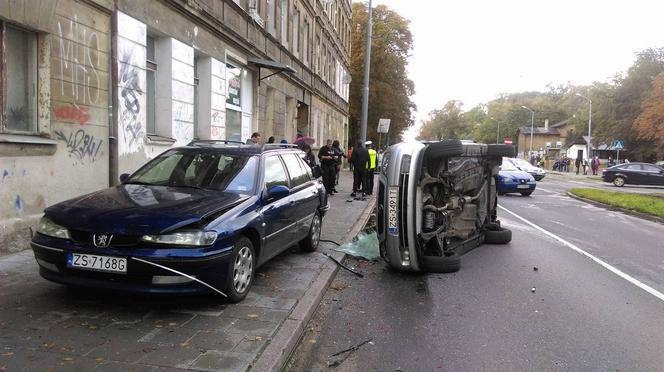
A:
31;141;329;302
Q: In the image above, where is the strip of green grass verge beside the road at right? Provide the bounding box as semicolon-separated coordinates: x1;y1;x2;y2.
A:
569;188;664;218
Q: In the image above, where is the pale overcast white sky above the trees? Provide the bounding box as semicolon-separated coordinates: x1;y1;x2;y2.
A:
366;0;664;138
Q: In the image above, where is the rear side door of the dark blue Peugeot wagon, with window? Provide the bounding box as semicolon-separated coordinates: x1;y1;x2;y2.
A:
282;153;319;243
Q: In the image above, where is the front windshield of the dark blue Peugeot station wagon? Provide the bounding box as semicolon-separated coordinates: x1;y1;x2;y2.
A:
125;150;258;194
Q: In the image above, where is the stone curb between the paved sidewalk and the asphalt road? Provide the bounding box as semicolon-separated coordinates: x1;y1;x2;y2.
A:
247;198;376;372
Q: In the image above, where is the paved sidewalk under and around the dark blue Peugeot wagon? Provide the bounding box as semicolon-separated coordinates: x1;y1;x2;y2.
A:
0;171;375;372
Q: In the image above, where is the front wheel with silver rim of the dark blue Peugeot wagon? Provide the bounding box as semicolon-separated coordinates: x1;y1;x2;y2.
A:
223;236;256;303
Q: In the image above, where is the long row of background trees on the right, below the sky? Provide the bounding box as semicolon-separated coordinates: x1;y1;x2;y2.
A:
420;48;664;161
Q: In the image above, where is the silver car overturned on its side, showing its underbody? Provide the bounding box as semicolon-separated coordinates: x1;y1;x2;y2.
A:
377;140;514;272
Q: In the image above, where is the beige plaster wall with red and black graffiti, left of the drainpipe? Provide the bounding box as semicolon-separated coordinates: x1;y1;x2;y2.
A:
0;0;111;254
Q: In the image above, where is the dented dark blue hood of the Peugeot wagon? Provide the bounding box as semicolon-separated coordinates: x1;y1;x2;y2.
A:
45;184;248;235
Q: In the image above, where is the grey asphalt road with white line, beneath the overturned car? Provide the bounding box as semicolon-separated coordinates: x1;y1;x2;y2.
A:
287;178;664;371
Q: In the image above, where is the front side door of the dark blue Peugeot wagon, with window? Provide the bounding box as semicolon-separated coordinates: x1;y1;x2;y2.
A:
261;155;294;261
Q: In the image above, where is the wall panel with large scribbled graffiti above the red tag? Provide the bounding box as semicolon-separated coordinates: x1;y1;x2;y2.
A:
58;16;100;104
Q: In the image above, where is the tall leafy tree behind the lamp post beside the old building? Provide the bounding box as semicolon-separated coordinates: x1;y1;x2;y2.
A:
350;3;416;148
